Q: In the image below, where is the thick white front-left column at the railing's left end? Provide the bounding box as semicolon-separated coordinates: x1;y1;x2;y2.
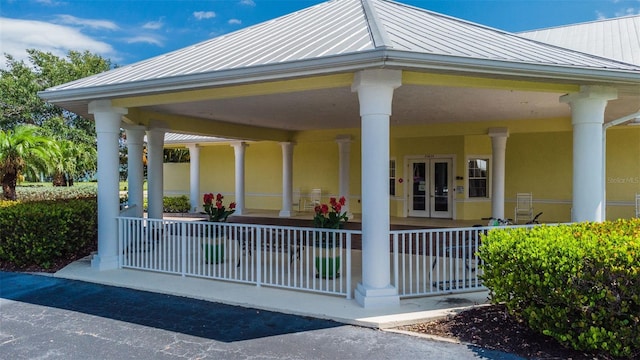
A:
89;100;127;270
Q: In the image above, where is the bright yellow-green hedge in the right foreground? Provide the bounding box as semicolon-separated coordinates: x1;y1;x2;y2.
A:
479;219;640;357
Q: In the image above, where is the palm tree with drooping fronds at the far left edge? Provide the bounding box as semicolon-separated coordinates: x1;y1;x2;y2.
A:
0;125;60;200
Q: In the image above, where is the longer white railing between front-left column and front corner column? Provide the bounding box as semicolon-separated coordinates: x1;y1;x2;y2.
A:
118;217;359;298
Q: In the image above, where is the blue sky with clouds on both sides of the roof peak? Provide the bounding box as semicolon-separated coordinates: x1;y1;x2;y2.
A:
0;0;640;68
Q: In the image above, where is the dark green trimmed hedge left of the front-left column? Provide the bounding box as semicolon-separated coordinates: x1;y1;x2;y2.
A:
0;198;98;269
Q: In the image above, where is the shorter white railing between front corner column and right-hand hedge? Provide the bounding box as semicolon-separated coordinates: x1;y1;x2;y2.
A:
391;227;492;297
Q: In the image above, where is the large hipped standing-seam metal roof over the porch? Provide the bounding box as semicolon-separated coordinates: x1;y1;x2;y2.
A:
42;0;640;95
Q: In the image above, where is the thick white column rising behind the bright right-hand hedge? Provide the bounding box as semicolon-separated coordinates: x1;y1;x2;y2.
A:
560;86;617;222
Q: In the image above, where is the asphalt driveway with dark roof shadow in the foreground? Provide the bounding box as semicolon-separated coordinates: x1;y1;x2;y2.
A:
0;272;519;360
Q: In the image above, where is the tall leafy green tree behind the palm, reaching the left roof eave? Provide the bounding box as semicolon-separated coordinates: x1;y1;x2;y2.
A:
0;49;111;185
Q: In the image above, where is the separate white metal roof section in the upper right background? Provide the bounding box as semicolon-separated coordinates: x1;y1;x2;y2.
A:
519;15;640;66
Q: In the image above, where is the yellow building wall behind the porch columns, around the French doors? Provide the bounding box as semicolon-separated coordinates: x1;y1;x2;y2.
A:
165;119;640;222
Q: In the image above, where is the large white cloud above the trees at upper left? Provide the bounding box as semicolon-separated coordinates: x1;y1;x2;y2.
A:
0;18;115;68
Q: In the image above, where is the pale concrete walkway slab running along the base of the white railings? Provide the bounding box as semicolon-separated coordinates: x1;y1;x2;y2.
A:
54;258;488;329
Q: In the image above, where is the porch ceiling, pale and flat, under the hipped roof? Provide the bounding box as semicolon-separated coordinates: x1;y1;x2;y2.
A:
135;85;640;135
